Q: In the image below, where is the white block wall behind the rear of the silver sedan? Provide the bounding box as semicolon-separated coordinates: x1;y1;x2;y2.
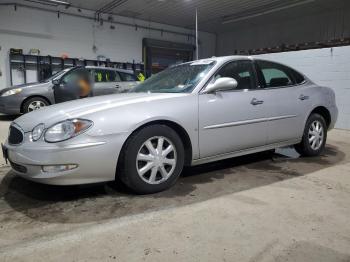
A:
256;46;350;129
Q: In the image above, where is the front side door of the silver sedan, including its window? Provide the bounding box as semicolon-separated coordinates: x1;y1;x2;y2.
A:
199;60;267;158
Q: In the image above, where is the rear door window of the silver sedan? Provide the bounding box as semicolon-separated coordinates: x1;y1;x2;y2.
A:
257;61;295;88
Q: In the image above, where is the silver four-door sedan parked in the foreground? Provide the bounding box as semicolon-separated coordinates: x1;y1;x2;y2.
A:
3;56;338;193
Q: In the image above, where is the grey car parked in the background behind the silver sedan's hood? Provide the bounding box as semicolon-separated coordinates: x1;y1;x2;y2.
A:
0;66;137;114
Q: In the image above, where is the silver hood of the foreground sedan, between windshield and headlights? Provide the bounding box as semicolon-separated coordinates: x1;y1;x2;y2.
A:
14;93;189;132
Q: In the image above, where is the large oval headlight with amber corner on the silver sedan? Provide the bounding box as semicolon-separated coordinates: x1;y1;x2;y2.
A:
44;119;93;143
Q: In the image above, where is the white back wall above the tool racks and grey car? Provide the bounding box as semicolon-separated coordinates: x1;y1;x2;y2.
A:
0;6;216;89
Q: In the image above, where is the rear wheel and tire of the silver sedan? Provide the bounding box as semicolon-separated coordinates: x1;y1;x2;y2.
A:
294;114;327;156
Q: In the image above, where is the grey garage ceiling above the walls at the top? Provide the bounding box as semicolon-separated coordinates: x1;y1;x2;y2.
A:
17;0;346;33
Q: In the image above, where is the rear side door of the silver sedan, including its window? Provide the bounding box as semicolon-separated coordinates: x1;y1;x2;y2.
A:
256;60;307;144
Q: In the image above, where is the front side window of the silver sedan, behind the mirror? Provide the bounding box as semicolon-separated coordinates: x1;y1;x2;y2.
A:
214;61;256;89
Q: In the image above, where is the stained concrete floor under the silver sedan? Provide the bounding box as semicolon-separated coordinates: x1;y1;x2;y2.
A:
0;117;350;262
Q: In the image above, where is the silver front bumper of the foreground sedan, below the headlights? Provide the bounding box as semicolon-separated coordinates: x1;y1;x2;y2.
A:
5;134;127;185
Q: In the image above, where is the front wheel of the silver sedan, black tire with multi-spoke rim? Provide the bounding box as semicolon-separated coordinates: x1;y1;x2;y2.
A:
116;125;184;194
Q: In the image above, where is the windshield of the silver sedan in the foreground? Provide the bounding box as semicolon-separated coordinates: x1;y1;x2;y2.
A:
130;60;215;93
